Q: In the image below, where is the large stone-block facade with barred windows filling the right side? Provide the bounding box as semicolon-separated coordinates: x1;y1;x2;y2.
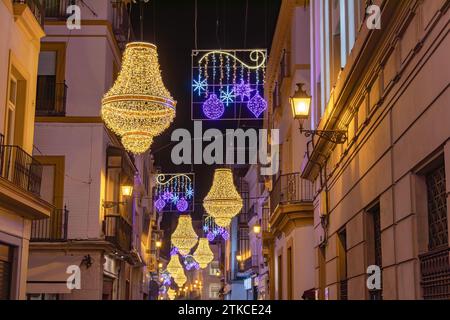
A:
302;0;450;300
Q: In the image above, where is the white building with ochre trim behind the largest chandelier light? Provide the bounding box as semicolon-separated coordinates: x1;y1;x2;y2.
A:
27;0;157;300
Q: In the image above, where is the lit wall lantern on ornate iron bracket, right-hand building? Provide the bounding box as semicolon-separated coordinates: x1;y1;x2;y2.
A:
289;83;347;144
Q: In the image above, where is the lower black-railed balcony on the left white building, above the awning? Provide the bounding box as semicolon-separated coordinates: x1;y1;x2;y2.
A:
30;208;69;242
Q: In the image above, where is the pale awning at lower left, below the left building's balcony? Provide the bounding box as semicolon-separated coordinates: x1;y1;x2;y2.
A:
27;254;83;294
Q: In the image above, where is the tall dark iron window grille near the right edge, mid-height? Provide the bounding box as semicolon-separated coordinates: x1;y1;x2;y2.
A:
426;165;448;251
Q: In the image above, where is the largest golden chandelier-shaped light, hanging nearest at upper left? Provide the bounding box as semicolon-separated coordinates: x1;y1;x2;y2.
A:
101;42;176;154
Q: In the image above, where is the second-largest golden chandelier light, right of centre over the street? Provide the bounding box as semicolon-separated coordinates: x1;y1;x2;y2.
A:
203;169;243;228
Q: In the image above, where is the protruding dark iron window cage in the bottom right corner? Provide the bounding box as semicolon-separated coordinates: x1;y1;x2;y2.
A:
419;245;450;300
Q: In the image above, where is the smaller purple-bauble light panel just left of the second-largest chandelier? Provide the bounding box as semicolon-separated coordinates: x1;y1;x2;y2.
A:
153;173;195;213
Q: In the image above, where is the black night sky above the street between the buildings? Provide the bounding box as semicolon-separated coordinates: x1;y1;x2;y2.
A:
128;0;280;255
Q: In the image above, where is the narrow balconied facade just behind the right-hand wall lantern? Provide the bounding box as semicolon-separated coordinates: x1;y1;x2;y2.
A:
261;1;315;300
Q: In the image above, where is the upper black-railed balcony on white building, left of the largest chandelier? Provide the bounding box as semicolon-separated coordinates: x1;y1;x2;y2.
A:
36;76;67;117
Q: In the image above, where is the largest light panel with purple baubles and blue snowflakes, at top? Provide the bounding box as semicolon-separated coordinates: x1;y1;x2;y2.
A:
191;49;267;120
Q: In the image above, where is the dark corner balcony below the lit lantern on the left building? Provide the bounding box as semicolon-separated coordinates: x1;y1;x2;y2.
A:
103;215;132;252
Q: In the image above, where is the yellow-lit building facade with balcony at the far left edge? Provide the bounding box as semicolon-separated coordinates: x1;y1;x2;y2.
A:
0;0;52;300
